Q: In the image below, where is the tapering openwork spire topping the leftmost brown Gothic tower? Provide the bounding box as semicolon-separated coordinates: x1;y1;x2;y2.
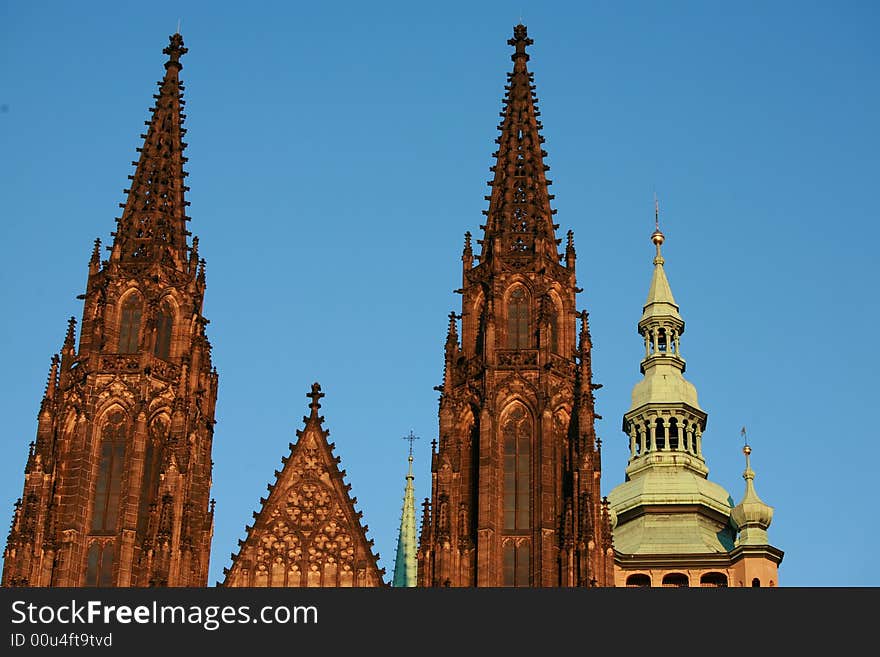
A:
111;34;189;266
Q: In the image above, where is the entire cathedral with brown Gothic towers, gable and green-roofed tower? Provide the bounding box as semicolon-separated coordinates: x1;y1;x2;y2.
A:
2;24;783;587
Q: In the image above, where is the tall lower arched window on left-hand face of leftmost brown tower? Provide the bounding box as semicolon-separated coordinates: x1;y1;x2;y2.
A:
92;409;126;533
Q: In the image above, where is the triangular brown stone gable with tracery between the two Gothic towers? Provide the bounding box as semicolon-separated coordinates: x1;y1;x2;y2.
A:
222;383;385;588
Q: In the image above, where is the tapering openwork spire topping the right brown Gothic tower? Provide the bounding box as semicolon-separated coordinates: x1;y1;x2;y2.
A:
480;24;559;262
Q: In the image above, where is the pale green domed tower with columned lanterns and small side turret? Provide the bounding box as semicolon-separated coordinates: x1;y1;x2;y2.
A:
608;209;782;586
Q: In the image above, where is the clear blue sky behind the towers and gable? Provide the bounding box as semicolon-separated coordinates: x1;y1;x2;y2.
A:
0;0;880;586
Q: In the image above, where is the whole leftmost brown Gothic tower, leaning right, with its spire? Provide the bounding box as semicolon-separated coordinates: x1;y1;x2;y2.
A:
2;34;217;587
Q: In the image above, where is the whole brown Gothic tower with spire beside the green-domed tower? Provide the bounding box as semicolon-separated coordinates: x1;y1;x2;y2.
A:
418;25;613;587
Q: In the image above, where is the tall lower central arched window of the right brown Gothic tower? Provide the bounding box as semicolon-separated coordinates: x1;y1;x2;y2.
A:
501;405;532;529
